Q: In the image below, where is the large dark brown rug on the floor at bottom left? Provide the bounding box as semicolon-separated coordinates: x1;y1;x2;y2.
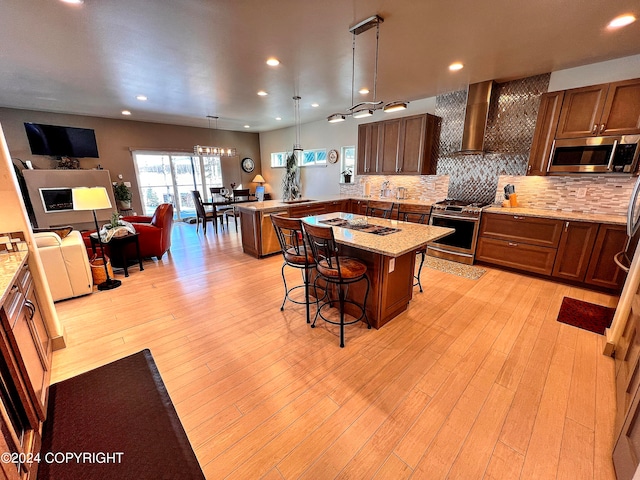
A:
38;350;205;480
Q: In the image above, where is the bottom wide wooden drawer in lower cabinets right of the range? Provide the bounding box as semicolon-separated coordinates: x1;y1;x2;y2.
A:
476;237;556;275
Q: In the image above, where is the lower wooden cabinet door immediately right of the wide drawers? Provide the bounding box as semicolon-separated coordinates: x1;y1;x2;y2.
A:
553;222;596;282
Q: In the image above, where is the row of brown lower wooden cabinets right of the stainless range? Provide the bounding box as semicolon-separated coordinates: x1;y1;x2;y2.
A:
475;213;627;291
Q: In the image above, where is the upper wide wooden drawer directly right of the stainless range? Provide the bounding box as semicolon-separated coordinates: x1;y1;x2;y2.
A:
480;213;563;248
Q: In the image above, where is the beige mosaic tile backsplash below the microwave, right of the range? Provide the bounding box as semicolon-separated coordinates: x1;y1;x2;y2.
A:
495;175;637;215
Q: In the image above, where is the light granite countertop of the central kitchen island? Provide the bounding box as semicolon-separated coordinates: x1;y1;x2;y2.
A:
302;213;455;257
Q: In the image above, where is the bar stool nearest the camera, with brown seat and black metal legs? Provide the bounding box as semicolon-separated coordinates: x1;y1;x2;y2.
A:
302;223;371;348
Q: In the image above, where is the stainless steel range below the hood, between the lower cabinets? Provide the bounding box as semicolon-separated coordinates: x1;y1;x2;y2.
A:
427;199;487;265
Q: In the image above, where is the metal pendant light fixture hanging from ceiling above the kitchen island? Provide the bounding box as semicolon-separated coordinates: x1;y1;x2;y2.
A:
327;15;408;123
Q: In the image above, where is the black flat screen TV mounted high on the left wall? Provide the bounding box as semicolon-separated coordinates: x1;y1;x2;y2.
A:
24;122;98;158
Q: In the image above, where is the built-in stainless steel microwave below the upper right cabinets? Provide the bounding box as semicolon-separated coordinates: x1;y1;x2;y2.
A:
547;135;640;173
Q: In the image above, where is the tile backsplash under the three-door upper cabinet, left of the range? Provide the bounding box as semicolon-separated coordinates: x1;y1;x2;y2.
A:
340;175;449;203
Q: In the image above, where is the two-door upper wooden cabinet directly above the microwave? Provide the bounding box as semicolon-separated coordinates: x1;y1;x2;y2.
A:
555;79;640;138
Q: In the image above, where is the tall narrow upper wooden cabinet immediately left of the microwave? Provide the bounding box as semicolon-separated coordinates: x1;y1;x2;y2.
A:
527;92;564;175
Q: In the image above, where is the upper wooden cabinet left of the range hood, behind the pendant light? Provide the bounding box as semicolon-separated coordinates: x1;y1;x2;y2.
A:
357;114;439;175
